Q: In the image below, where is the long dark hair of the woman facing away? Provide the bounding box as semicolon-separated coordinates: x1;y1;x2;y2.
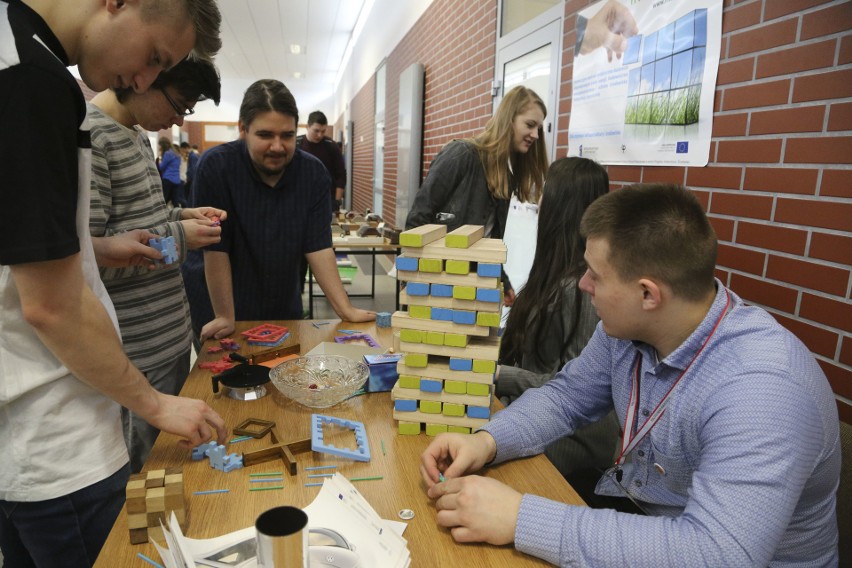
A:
500;157;609;365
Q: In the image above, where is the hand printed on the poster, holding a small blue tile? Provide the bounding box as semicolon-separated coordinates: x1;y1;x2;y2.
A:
575;0;639;62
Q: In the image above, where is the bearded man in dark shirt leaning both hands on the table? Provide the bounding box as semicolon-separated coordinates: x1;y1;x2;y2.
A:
182;79;376;342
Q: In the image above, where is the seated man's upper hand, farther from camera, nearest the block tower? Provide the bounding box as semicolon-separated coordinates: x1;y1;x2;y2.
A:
420;432;497;488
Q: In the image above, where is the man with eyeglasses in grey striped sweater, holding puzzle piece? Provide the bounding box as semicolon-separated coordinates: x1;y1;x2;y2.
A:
87;58;227;473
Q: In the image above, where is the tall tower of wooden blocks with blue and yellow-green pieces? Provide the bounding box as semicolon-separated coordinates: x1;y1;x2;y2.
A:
392;225;506;436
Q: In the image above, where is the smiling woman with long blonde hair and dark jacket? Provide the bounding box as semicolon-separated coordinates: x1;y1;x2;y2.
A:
405;86;548;305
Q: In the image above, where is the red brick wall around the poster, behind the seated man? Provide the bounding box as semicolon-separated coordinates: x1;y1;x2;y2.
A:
557;0;852;422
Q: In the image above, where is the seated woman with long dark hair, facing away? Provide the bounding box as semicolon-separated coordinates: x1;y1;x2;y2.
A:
494;157;619;504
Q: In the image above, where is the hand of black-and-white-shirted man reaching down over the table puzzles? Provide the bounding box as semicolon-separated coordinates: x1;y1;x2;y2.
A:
139;391;228;448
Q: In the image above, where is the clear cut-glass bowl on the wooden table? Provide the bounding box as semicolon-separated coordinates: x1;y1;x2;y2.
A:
269;355;370;408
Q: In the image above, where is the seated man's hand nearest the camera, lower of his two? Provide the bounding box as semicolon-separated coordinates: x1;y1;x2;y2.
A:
429;475;522;545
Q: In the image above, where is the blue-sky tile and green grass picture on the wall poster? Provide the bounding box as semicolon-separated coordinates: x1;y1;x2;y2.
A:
623;9;707;125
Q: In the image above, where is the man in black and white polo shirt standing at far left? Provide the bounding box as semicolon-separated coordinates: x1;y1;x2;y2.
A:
0;0;227;568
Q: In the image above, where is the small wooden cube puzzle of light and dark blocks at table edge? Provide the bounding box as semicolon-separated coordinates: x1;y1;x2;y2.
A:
127;467;186;544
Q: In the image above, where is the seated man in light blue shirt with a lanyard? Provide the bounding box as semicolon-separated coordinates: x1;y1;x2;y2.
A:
421;185;840;566
